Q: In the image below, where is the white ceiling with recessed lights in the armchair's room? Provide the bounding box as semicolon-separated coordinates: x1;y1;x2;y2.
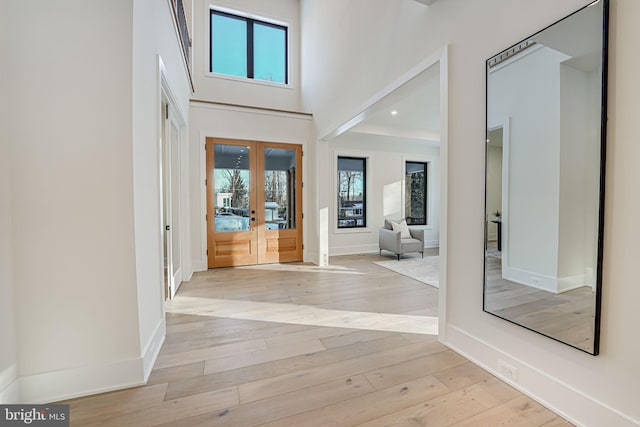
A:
336;64;440;147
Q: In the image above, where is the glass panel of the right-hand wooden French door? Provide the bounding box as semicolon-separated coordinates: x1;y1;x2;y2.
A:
264;147;297;230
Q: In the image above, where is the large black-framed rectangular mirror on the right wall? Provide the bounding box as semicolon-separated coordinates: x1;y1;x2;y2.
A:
484;0;608;355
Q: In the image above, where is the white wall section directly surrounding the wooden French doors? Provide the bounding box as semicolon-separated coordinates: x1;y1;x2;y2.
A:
189;102;314;271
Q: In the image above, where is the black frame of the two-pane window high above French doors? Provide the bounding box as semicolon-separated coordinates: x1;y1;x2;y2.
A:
209;9;289;85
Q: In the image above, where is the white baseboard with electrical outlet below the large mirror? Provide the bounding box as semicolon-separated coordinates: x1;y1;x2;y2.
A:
444;325;640;427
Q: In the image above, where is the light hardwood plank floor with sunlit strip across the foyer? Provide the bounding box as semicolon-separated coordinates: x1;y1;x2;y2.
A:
60;253;571;427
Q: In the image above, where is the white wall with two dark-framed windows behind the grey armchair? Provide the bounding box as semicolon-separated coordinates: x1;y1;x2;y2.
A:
318;136;440;256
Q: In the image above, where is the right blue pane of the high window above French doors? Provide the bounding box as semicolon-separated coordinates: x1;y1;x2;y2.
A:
253;22;287;83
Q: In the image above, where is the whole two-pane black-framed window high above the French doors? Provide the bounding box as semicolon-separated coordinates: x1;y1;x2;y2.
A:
209;9;289;84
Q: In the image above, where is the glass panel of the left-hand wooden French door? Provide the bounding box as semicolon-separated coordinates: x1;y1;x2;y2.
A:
213;144;251;231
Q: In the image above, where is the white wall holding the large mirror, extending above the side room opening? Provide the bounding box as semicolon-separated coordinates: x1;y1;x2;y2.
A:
301;0;640;426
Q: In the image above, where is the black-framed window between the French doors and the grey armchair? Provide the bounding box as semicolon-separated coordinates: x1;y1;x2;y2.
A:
338;157;367;228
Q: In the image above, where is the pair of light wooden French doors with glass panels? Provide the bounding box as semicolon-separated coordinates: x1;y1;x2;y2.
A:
206;138;302;268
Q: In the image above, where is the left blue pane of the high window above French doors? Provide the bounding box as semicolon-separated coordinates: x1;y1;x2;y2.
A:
211;13;247;77
